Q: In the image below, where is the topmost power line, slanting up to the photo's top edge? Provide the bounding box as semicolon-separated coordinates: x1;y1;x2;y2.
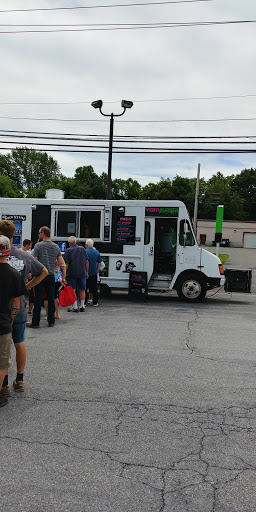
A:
0;0;213;13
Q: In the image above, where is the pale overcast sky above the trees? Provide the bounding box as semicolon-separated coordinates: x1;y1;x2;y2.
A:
0;0;256;185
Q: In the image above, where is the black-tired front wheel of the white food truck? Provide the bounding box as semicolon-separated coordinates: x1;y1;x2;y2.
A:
176;274;207;303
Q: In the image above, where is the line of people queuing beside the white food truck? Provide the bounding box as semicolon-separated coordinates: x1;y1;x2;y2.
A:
0;220;103;407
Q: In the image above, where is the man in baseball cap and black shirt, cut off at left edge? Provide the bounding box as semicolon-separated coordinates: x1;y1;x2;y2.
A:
0;235;26;407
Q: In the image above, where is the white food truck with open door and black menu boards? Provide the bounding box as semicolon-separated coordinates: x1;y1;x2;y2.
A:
0;195;225;302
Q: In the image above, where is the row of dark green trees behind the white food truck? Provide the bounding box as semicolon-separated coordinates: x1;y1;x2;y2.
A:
0;147;256;221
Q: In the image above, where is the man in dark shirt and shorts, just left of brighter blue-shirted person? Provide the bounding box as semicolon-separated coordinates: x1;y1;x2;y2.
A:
64;236;89;313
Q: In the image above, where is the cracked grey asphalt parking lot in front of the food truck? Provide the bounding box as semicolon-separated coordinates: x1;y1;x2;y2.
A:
0;282;256;512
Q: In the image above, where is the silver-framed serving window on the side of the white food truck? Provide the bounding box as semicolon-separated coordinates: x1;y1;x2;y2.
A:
55;209;101;239
